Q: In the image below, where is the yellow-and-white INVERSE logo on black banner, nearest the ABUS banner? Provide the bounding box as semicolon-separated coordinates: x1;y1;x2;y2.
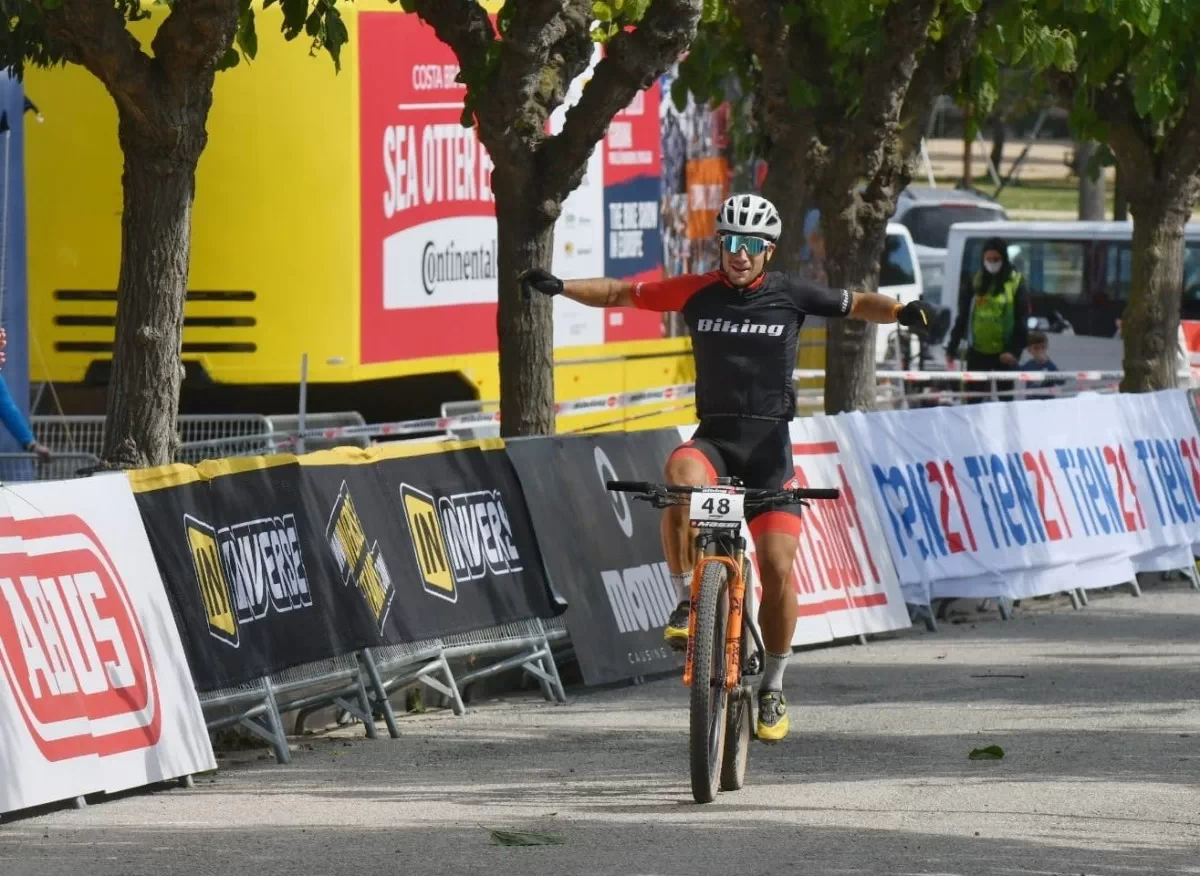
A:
184;514;312;648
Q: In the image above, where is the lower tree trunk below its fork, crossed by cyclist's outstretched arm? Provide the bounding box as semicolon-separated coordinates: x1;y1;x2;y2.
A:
821;202;887;414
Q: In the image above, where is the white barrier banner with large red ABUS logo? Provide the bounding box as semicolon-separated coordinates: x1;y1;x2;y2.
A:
0;475;215;811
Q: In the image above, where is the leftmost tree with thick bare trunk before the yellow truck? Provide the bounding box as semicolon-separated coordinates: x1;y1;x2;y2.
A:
0;0;347;468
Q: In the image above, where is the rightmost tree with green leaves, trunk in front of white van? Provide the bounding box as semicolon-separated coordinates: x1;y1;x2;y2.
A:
1045;0;1200;391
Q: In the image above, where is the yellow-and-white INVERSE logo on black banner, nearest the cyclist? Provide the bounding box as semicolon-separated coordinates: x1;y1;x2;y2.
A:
400;484;523;602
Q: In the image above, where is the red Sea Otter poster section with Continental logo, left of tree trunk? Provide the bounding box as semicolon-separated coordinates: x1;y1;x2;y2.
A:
359;12;497;362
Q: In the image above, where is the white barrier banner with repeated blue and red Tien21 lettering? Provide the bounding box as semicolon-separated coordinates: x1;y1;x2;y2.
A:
834;390;1200;598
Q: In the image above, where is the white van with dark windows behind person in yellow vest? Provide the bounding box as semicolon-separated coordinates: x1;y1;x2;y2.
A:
942;222;1200;371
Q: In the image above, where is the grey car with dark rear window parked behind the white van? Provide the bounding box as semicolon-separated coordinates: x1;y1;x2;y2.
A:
892;186;1008;307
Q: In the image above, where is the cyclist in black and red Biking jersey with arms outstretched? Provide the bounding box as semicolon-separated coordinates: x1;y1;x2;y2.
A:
521;194;932;742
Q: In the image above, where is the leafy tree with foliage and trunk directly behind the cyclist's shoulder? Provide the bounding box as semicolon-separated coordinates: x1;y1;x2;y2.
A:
679;0;1072;413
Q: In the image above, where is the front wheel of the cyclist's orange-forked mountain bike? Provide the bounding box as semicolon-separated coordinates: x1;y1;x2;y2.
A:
688;563;730;803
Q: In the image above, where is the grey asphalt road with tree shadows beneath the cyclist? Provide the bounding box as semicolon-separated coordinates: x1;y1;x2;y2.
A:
0;588;1200;876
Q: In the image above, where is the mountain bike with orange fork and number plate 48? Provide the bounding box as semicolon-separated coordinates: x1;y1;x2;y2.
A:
605;478;840;803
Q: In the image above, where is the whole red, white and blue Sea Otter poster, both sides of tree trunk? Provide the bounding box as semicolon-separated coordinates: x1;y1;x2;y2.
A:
359;12;662;364
